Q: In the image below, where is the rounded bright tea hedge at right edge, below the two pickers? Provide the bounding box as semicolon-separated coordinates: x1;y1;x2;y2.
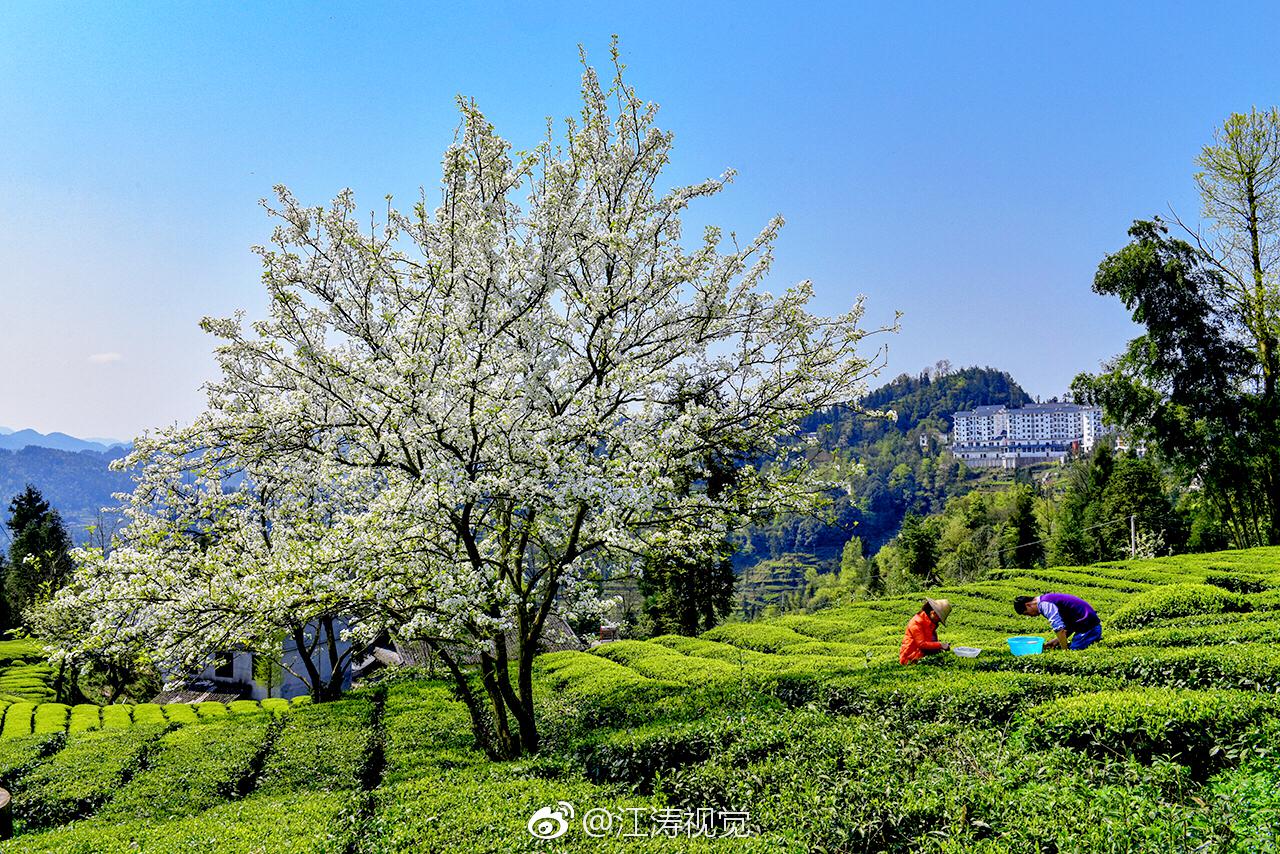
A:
1023;688;1280;769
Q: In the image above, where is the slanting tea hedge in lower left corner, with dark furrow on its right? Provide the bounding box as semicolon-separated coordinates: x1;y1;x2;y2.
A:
14;727;161;827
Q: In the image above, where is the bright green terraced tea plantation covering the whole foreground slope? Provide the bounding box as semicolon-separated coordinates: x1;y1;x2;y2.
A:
0;548;1280;854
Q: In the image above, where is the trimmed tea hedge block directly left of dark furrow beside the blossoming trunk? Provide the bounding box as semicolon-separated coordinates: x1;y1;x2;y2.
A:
259;699;374;793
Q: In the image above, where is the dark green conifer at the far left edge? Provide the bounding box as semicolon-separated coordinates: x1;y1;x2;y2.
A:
4;484;73;624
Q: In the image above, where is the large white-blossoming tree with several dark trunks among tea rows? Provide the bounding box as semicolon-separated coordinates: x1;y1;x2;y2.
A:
35;51;874;757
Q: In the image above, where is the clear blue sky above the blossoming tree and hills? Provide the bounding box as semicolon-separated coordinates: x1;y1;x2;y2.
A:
0;1;1280;438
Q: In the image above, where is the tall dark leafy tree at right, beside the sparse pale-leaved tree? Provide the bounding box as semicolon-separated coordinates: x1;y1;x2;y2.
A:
1071;219;1280;547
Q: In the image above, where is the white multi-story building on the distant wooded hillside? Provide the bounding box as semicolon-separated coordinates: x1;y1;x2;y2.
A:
951;403;1108;469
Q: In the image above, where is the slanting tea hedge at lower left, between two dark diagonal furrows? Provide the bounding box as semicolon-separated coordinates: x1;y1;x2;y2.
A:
99;712;273;821
